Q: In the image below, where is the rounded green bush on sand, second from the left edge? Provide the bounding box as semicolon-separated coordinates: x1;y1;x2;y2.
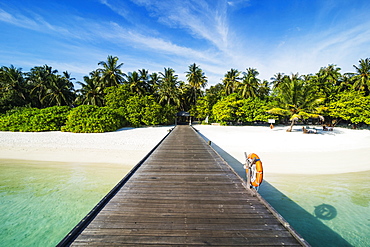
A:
62;105;124;133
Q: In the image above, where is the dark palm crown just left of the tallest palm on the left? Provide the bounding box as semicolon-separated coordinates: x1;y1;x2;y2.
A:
76;70;104;106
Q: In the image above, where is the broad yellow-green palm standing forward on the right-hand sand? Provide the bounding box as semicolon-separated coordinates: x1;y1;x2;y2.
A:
269;74;321;132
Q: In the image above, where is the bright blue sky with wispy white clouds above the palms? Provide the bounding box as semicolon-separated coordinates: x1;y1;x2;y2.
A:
0;0;370;85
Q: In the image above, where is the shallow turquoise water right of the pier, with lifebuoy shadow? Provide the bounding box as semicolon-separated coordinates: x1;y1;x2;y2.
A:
259;171;370;247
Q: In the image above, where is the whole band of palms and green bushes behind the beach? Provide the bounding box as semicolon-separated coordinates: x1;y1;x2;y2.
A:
0;56;370;132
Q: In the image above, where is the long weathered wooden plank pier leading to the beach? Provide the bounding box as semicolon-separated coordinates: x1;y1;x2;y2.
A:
59;126;309;246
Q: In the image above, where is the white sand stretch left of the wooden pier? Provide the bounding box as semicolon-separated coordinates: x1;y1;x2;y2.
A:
0;127;170;166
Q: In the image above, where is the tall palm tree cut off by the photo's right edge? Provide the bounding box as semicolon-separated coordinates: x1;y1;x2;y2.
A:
353;58;370;96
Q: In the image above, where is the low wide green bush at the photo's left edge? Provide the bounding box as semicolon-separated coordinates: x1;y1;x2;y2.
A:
0;106;70;132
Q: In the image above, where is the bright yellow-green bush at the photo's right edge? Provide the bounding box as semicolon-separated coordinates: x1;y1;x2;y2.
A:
329;92;370;124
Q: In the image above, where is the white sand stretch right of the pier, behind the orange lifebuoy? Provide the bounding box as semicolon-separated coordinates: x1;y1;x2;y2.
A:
196;125;370;174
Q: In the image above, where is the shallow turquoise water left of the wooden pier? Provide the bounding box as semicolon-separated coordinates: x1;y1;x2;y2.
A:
0;160;130;246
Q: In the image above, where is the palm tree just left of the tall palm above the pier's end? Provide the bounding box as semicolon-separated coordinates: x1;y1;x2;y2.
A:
157;68;180;107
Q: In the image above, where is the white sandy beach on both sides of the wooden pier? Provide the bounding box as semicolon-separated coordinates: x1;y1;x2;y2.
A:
0;125;370;174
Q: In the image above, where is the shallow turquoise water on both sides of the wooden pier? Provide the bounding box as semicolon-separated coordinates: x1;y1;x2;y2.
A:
0;157;370;247
